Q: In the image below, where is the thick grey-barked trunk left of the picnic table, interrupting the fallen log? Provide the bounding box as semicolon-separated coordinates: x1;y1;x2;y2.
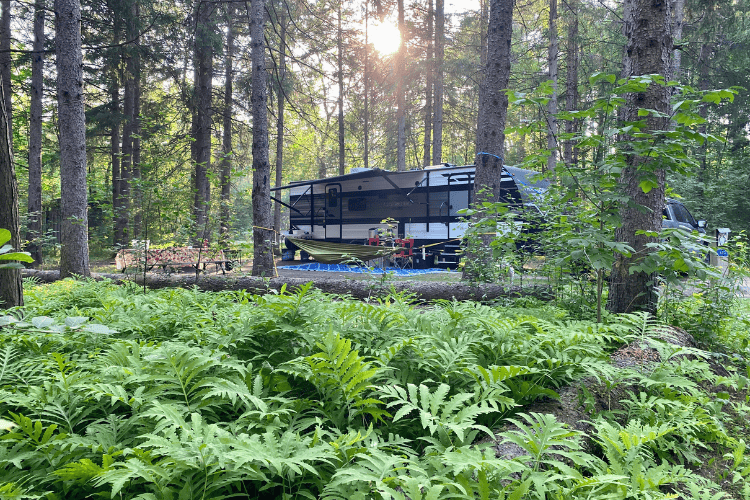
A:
55;0;91;278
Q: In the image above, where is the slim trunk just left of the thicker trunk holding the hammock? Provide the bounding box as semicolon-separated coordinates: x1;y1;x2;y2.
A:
219;3;234;245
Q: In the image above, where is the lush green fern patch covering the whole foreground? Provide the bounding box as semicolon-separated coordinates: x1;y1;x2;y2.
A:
0;280;750;500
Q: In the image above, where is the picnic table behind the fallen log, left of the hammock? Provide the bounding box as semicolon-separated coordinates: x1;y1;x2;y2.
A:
115;247;232;273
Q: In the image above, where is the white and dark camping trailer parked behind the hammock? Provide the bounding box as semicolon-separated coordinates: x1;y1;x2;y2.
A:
272;164;549;267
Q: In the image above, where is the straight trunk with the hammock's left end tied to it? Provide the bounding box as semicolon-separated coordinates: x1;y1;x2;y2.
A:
250;0;273;276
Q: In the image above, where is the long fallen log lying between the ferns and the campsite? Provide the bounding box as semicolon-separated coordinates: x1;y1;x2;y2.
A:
23;269;552;302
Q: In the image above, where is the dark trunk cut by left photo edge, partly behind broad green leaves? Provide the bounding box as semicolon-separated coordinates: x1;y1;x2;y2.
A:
0;74;23;309
